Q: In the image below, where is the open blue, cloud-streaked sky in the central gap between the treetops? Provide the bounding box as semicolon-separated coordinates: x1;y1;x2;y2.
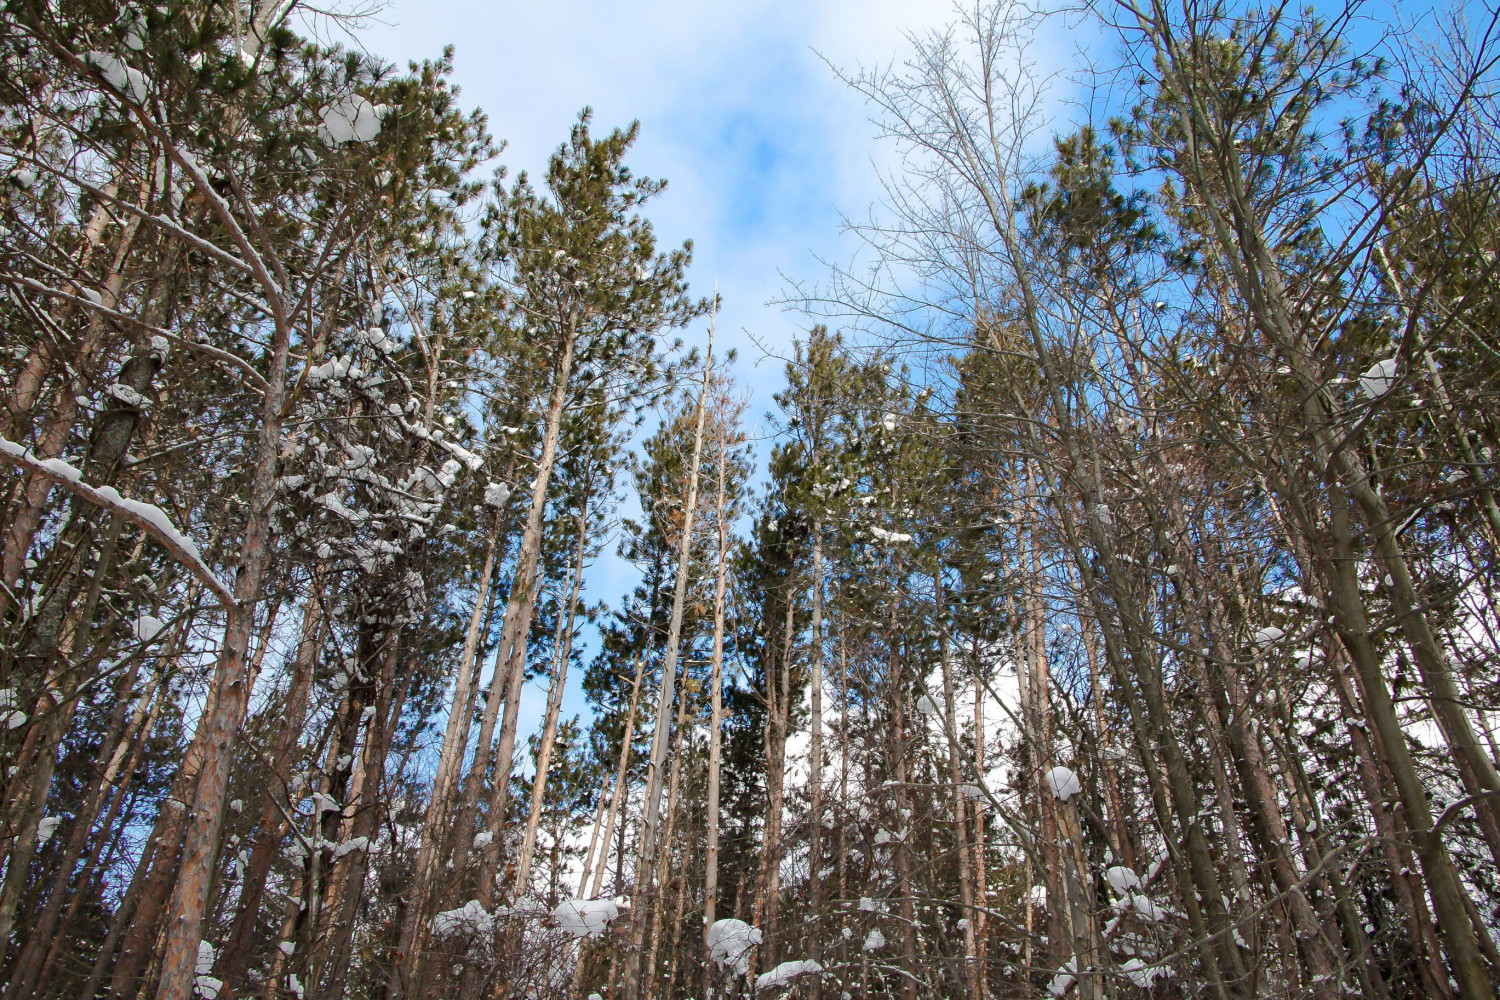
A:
343;0;996;761
